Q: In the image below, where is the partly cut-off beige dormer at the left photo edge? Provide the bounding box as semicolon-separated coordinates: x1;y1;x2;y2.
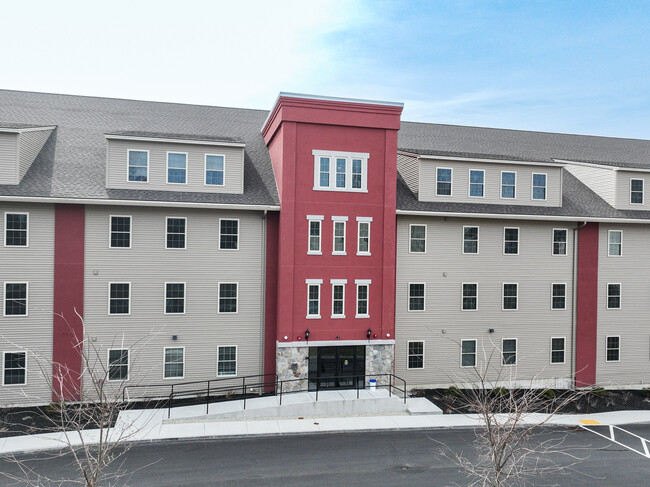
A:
0;122;56;185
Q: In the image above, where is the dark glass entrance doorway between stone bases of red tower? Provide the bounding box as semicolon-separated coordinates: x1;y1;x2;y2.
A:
309;345;366;390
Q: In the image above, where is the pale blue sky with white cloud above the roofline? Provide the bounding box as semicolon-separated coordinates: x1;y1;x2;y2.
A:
0;0;650;139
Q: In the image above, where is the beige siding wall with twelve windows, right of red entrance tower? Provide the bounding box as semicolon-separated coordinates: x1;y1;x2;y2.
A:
395;217;573;387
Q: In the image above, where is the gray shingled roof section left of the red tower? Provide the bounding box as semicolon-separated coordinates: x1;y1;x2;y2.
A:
0;90;279;205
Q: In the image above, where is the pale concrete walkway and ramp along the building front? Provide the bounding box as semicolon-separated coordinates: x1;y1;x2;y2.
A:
0;390;650;455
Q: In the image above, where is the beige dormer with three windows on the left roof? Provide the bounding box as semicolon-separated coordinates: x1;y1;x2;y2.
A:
105;132;245;194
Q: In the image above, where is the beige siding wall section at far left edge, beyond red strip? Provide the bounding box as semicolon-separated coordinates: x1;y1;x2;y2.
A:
0;203;54;405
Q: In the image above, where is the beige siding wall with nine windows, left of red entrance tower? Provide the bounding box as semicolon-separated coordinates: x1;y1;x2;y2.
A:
84;207;264;400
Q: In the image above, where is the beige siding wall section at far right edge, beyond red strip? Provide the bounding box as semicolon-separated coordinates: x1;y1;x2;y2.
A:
596;224;650;386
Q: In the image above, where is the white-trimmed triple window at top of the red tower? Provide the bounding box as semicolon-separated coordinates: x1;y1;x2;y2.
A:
312;150;370;192
